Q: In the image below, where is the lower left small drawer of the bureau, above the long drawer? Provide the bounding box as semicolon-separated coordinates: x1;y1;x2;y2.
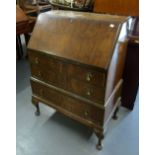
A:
31;64;65;88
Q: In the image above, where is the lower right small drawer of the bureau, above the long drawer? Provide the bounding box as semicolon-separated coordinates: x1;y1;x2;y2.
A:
68;78;104;104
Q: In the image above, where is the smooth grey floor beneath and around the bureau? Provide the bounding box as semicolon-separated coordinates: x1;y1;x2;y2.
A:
16;59;139;155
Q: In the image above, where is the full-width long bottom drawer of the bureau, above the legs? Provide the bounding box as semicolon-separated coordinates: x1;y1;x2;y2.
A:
31;80;103;125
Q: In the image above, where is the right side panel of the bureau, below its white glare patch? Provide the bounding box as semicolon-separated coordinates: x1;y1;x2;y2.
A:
104;41;127;125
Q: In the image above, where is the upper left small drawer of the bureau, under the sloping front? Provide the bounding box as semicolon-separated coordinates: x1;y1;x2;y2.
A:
29;51;62;72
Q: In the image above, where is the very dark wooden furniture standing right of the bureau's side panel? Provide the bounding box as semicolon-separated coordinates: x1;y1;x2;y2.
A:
122;18;139;110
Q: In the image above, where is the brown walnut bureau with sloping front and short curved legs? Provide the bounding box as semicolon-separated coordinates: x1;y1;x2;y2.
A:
28;11;128;149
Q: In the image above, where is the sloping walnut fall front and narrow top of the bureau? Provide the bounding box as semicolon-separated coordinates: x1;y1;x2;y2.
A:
28;11;127;69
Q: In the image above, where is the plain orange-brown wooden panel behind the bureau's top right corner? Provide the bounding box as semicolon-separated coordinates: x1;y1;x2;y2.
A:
94;0;139;16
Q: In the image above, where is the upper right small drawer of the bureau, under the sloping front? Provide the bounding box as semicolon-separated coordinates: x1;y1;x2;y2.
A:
68;64;105;87
